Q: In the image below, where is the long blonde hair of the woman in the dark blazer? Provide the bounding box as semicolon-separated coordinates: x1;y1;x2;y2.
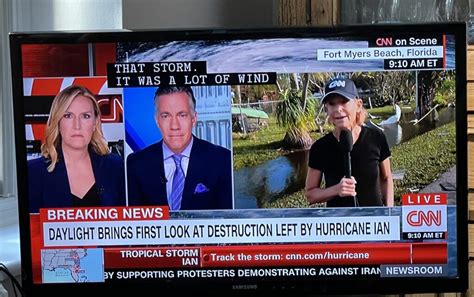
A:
41;85;110;172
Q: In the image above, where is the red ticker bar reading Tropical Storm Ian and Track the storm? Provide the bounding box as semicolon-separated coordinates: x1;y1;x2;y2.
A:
104;242;448;269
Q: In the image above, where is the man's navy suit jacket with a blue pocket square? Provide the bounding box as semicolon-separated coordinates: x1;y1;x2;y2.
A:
127;137;232;210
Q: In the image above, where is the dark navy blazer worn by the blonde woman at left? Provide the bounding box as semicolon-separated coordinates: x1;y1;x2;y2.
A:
28;152;125;213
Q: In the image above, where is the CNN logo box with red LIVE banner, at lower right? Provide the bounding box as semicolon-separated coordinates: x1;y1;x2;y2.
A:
402;193;448;232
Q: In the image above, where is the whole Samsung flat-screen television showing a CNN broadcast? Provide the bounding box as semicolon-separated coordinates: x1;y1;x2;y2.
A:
10;23;468;296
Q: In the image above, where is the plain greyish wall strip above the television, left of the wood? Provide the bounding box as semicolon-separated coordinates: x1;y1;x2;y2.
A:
122;0;278;29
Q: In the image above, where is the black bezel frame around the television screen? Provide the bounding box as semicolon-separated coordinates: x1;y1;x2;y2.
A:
10;23;468;296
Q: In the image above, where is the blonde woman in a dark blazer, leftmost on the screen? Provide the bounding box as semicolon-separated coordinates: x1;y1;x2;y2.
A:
28;86;125;213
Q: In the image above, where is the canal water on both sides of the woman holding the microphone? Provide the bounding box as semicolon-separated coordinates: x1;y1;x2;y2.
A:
234;108;456;209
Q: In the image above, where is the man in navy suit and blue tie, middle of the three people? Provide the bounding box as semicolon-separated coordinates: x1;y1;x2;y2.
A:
127;86;232;210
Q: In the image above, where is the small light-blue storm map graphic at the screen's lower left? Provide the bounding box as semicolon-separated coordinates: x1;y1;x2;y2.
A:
41;248;104;283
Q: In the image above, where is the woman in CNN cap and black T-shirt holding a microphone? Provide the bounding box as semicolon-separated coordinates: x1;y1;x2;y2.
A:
305;78;393;207
